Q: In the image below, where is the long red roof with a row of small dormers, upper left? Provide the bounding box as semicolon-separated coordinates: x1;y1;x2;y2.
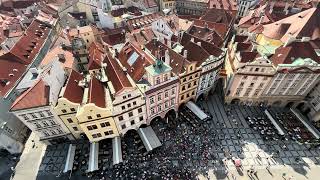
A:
10;19;51;64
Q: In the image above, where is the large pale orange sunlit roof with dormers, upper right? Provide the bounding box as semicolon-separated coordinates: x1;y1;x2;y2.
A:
262;8;320;42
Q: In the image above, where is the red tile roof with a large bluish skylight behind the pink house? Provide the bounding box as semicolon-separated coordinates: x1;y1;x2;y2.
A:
119;42;154;82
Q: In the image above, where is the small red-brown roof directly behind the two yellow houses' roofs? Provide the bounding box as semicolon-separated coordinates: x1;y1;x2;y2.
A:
88;42;104;70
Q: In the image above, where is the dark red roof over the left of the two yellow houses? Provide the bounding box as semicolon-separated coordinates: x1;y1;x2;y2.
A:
63;70;84;104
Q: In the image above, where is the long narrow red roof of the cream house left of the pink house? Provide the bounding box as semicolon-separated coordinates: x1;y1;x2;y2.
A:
104;52;132;93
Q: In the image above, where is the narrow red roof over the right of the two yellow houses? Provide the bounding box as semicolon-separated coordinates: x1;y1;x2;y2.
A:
88;77;106;108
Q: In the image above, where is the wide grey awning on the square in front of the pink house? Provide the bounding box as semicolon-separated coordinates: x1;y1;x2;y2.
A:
138;126;161;151
